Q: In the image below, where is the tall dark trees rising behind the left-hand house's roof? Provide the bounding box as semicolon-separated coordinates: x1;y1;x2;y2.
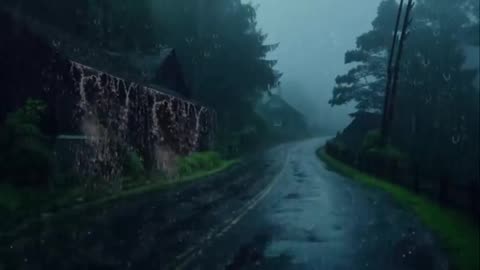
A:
2;0;281;154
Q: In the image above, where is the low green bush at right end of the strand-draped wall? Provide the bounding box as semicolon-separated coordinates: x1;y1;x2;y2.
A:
177;152;223;176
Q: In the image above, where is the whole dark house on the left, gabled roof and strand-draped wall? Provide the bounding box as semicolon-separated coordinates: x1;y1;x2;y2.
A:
0;10;216;185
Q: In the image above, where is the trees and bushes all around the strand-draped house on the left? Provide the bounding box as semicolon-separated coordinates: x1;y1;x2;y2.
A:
0;0;292;219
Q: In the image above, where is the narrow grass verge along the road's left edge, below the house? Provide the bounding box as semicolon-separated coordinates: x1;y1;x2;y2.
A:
0;159;240;235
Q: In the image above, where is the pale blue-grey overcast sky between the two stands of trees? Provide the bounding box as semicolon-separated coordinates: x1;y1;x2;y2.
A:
246;0;381;133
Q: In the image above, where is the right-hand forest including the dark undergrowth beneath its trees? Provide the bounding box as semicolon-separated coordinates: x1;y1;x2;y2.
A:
330;0;480;211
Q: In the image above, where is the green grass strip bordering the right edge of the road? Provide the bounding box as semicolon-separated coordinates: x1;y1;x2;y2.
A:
317;148;480;270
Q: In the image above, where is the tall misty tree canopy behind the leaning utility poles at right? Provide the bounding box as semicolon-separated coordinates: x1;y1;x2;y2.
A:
330;0;479;184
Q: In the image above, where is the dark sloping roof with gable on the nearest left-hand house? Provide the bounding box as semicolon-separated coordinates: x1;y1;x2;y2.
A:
8;11;190;97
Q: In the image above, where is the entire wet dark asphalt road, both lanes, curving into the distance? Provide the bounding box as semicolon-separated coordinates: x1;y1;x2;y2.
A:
0;139;449;270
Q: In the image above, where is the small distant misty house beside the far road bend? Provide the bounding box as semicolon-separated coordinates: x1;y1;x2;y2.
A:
257;94;308;137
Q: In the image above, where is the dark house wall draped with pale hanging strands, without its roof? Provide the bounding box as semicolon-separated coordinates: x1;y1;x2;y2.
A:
0;12;216;186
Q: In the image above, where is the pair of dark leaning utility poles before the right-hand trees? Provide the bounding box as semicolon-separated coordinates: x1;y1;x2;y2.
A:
381;0;415;145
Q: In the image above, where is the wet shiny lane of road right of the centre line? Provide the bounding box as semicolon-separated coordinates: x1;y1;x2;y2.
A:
182;139;449;270
